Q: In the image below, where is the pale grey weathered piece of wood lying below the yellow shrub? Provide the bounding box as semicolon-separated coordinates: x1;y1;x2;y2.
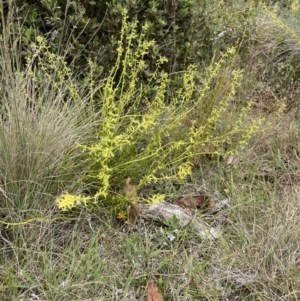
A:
140;202;220;239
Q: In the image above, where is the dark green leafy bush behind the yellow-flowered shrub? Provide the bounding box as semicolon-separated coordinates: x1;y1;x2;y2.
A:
3;0;212;77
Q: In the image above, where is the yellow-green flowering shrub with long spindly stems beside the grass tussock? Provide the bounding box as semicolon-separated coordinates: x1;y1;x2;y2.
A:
58;11;274;210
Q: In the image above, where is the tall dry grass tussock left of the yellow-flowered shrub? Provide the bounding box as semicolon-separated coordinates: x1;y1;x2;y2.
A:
0;24;101;223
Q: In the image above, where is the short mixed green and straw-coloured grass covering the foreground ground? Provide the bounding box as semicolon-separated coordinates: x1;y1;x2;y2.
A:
0;1;300;301
